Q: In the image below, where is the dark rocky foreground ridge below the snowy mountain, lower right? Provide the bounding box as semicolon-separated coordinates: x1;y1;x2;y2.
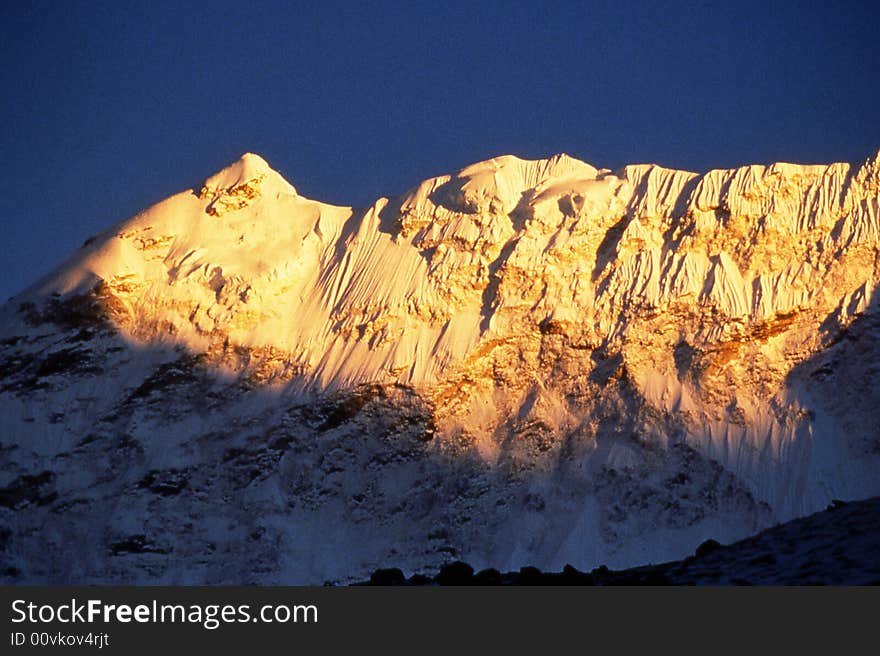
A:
361;497;880;585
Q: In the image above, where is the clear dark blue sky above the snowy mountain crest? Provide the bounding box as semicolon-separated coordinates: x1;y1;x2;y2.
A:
0;0;880;298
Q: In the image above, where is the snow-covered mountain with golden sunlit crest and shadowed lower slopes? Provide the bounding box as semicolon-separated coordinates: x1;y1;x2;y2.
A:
0;153;880;584
